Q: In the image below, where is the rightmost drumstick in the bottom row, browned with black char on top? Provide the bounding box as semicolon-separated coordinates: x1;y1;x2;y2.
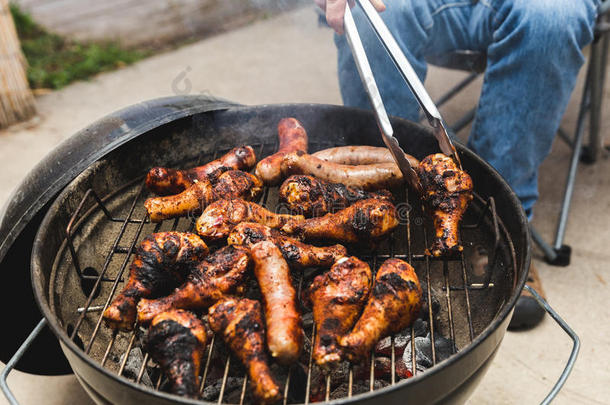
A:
338;259;422;361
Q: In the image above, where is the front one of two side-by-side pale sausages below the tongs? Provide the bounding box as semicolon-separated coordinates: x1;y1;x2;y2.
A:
281;151;403;191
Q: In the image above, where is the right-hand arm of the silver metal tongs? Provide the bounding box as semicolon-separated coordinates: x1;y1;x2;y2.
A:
358;0;462;169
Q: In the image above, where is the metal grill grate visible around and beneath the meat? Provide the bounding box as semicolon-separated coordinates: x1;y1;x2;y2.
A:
52;143;516;404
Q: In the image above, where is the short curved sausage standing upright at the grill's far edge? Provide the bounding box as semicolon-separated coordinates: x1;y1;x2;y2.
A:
255;118;307;185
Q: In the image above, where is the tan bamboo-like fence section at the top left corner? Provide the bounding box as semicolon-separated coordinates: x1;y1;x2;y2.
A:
0;0;36;128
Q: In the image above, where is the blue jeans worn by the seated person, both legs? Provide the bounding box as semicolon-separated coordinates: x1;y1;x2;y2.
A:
335;0;599;217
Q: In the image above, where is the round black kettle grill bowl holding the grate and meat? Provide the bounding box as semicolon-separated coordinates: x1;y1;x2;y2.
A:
32;104;530;404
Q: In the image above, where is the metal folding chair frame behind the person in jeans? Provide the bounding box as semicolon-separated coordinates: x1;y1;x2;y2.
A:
428;0;610;266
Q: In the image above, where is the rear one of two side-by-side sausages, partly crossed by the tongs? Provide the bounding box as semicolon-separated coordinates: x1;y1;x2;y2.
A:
312;145;419;167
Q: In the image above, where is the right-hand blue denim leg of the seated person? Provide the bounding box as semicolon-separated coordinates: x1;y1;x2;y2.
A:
468;0;598;217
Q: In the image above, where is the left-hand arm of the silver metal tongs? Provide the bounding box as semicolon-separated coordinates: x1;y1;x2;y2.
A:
343;4;423;195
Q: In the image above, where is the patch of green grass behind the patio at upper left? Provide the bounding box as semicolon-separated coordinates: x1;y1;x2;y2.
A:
11;4;148;89
